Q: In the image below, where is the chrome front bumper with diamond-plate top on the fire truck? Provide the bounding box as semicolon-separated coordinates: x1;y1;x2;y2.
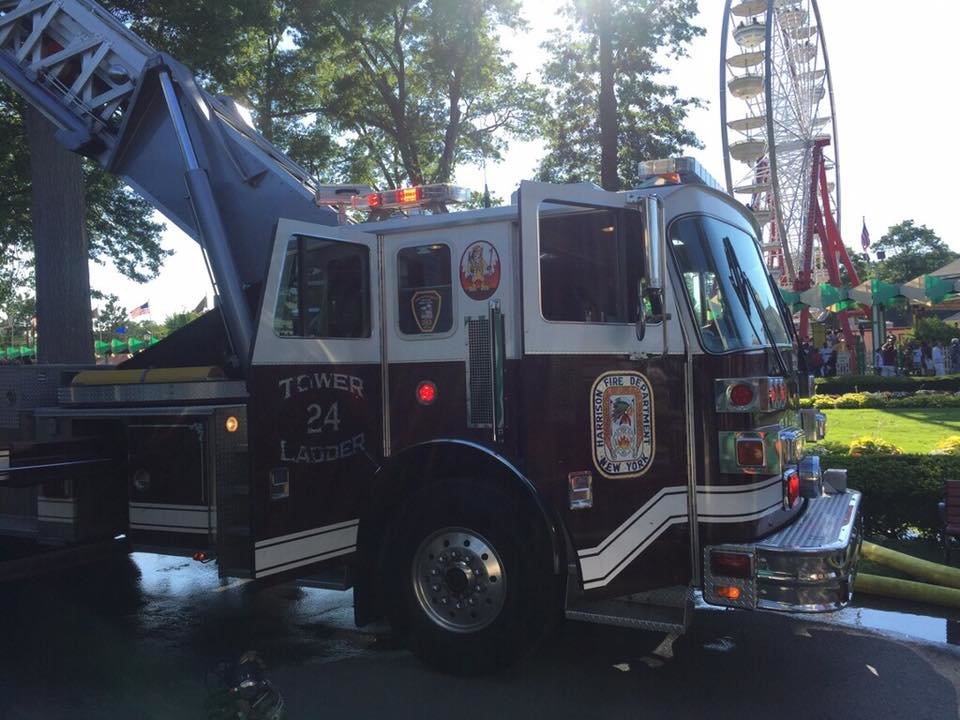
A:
703;490;862;612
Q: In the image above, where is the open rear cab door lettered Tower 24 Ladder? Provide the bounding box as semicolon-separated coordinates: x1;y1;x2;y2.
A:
249;220;382;577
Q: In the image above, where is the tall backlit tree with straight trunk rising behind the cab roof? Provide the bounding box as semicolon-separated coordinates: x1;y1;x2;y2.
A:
538;0;704;190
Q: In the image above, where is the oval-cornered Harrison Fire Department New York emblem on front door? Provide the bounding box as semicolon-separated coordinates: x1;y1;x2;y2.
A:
590;372;655;478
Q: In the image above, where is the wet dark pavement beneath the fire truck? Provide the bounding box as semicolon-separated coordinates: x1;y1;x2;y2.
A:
0;554;960;720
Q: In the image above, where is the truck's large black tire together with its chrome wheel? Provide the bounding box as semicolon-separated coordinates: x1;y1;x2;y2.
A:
381;481;560;674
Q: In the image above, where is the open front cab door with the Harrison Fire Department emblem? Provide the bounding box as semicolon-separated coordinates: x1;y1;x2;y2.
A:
520;183;690;596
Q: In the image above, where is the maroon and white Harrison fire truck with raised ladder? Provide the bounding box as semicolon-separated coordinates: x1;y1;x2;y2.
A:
0;0;860;671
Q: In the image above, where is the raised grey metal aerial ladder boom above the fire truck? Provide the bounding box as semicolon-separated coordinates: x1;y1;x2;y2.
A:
0;0;364;371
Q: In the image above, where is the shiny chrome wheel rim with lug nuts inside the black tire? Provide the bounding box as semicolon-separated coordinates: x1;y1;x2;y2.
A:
412;527;507;633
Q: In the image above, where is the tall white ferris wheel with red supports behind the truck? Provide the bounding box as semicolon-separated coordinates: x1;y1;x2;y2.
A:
720;0;849;291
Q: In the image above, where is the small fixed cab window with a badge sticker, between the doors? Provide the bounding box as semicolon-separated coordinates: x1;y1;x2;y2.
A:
397;244;453;335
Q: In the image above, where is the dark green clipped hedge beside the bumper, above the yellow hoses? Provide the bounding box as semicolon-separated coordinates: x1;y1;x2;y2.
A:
820;453;960;538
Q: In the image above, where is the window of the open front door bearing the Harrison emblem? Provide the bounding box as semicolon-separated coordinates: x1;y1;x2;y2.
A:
540;209;643;323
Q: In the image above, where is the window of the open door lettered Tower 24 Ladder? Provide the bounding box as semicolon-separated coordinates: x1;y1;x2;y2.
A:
273;236;370;338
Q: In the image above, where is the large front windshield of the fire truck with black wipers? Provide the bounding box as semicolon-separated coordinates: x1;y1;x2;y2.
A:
670;216;790;353
